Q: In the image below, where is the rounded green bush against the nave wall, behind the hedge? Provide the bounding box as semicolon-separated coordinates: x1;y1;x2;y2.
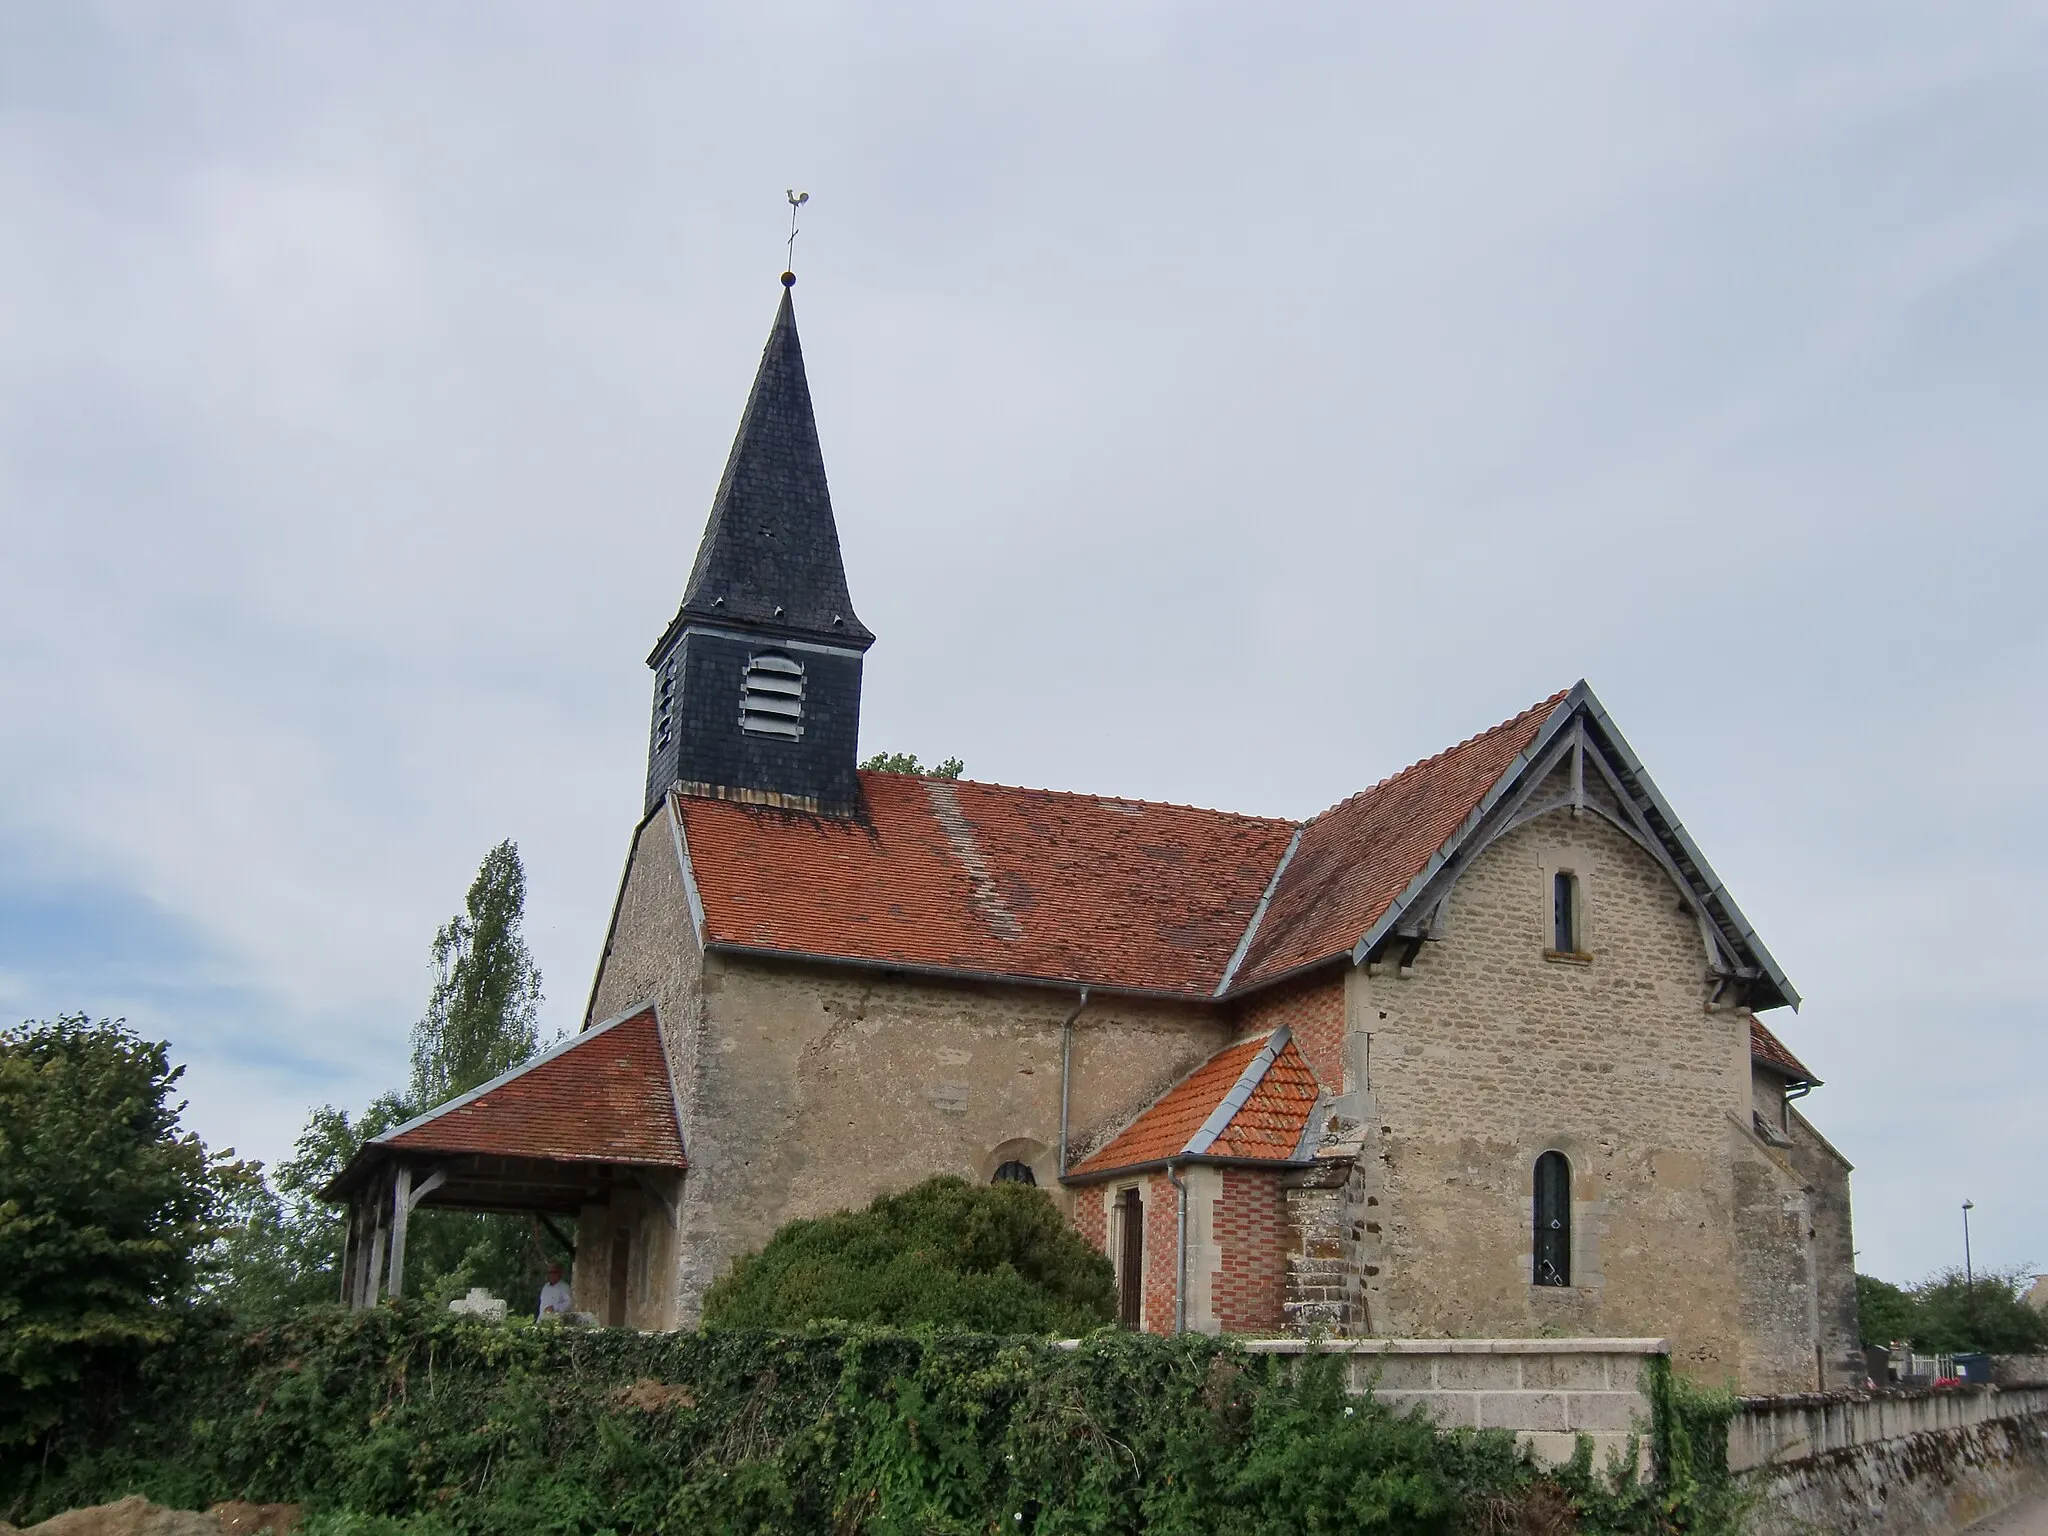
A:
705;1178;1116;1335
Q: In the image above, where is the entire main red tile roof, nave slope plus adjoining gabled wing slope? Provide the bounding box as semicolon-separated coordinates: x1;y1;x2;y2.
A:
674;692;1567;997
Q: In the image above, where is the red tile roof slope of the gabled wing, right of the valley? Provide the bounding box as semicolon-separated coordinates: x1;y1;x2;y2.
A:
1231;694;1565;991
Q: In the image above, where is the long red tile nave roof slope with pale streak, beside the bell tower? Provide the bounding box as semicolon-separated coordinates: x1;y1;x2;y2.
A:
676;774;1294;997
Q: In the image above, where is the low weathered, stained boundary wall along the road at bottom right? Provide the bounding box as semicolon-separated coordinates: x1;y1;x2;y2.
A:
1729;1386;2048;1536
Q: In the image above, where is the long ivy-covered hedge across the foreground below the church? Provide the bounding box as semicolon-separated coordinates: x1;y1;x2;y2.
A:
0;1305;1735;1536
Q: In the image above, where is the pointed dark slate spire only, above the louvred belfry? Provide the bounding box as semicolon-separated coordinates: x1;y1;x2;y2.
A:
678;279;874;649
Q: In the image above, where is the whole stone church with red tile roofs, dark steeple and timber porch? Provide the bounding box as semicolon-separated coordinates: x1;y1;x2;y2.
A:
332;274;1864;1393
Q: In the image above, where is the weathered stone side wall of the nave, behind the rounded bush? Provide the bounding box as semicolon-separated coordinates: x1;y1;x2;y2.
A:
680;954;1229;1327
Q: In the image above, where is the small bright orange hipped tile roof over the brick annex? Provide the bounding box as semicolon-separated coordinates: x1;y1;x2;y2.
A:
1071;1026;1319;1178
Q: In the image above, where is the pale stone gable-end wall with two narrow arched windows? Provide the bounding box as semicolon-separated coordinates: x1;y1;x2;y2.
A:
1352;811;1777;1380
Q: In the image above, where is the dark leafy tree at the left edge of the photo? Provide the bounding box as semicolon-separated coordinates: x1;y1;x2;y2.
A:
0;1014;258;1446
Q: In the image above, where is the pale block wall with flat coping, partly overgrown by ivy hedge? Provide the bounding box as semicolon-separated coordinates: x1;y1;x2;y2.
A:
1245;1339;1671;1466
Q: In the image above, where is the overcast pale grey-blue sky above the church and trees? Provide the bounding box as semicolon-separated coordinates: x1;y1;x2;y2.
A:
0;0;2048;1280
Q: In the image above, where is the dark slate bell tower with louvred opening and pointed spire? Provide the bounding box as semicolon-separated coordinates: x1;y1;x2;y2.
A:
647;272;874;815
